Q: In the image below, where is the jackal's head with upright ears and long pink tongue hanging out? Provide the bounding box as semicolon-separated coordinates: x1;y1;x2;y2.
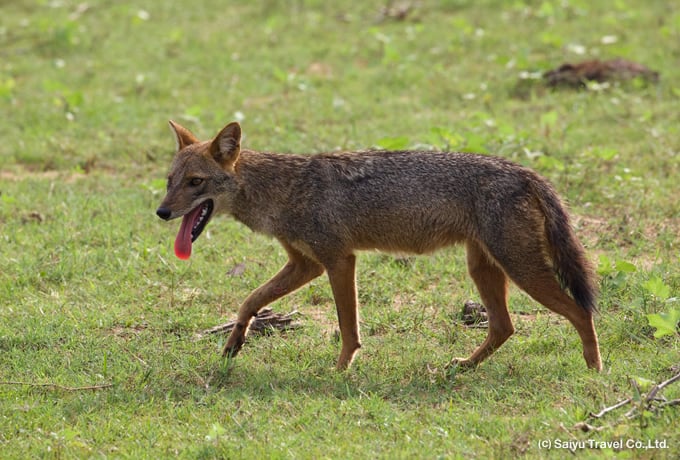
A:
156;121;241;259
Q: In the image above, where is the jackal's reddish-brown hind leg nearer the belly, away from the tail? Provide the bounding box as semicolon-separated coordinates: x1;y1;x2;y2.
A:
451;241;515;367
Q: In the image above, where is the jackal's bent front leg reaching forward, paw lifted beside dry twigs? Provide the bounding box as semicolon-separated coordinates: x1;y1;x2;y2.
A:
222;244;324;356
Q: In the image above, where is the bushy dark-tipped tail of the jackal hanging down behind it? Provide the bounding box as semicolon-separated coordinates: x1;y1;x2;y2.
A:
533;181;598;311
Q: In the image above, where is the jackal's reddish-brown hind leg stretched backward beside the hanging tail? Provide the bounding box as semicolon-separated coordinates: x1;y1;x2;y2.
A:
513;268;602;371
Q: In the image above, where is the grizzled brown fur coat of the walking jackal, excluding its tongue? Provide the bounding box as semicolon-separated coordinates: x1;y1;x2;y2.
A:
157;122;602;370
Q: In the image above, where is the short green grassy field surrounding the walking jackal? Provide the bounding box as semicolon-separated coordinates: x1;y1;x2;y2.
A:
0;0;680;459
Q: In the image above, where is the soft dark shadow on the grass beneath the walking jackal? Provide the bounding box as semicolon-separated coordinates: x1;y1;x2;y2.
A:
174;340;502;407
